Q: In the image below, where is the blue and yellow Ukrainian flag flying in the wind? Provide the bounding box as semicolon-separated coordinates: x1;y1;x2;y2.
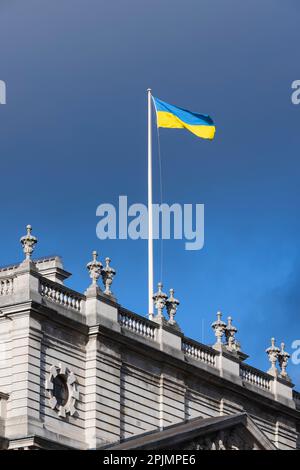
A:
153;96;216;140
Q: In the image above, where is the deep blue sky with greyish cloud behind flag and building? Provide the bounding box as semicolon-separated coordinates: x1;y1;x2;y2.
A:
0;0;300;389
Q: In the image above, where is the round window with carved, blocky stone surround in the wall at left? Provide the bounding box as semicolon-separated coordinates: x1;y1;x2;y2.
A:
45;363;79;418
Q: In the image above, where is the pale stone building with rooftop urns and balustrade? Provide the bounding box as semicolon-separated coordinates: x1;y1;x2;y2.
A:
0;226;300;450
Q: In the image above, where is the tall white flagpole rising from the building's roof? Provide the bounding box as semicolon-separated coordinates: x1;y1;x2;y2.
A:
147;88;153;319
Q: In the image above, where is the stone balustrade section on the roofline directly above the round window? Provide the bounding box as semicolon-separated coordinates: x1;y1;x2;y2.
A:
40;279;84;312
